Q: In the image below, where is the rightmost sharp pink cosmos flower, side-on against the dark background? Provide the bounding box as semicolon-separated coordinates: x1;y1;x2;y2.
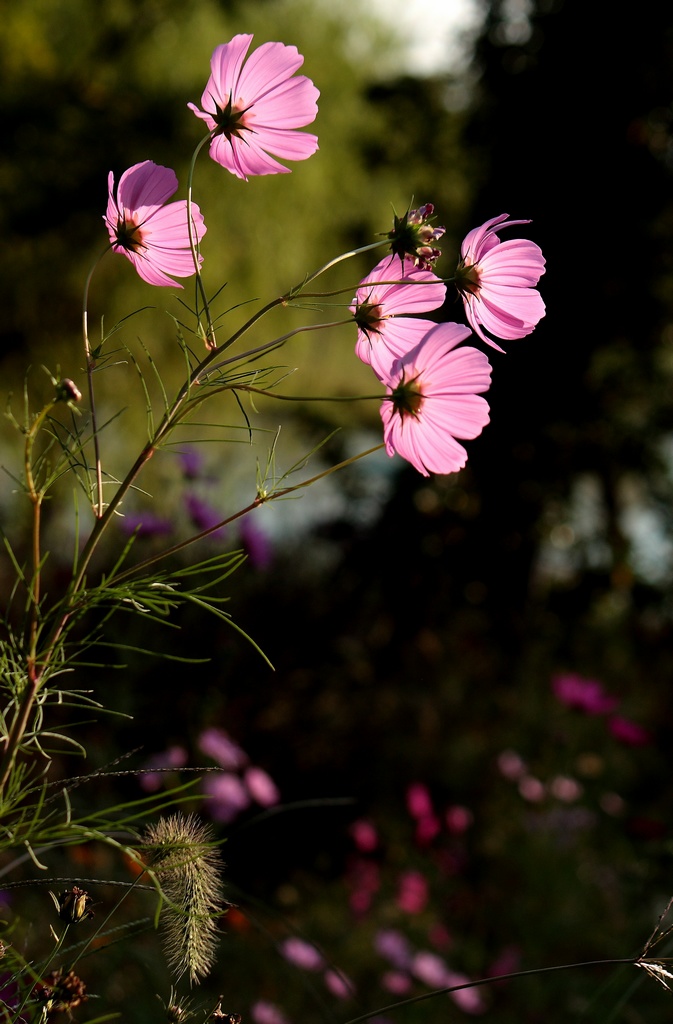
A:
455;213;545;352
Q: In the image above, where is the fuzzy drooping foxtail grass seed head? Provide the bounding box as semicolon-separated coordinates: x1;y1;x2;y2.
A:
142;814;222;984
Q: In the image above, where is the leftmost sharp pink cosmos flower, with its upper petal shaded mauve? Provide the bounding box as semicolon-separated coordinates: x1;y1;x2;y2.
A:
103;160;206;288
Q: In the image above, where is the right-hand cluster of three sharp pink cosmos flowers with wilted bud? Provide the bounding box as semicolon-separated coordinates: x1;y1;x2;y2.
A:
351;203;545;476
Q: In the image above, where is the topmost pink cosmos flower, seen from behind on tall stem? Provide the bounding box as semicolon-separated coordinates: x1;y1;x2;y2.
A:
188;35;320;181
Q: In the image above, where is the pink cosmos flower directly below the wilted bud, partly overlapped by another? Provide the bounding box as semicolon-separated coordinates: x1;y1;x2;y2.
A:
350;256;447;377
